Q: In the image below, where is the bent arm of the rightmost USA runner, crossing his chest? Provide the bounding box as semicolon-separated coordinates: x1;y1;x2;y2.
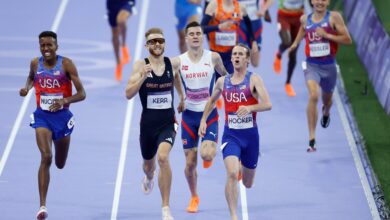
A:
316;11;352;44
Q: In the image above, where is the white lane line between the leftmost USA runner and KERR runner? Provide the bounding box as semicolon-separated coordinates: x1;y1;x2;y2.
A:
111;0;149;220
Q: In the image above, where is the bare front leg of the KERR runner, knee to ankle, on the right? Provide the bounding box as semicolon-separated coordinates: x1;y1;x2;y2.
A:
157;142;172;207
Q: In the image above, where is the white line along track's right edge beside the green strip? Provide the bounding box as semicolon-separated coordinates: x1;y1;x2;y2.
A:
334;88;381;220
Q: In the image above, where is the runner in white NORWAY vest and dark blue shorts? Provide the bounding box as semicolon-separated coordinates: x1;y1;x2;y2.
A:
172;22;228;213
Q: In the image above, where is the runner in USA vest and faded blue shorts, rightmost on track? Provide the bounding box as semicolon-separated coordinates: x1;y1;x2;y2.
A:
289;0;352;152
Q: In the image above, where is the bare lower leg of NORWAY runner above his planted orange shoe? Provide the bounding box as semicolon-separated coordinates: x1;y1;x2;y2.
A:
184;147;198;197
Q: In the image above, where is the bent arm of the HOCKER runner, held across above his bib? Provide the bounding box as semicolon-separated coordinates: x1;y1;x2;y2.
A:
237;74;272;117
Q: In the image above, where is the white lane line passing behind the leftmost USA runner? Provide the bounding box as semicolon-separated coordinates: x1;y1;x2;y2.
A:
0;0;69;177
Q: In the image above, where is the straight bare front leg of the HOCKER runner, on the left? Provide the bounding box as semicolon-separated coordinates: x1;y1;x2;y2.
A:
224;156;240;220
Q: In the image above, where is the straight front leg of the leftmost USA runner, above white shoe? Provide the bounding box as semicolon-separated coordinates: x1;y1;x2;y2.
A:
35;127;53;206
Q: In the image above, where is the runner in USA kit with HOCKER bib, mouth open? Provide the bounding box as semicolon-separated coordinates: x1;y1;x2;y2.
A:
199;44;272;220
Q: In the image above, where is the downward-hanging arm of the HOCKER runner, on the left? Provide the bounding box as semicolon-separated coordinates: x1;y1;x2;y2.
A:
198;76;225;137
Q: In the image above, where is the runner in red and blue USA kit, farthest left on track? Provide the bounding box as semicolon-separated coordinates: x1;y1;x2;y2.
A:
19;31;86;220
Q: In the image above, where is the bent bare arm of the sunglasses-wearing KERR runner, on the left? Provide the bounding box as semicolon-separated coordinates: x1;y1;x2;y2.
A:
126;60;152;99
